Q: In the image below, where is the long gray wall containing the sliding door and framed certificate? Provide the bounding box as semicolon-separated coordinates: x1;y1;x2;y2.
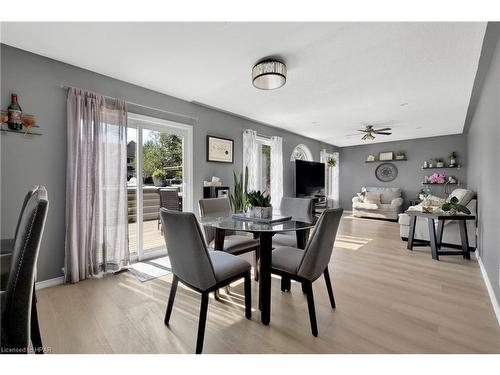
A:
0;45;335;280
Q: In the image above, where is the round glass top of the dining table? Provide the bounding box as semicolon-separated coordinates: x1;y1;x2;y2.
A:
199;212;318;232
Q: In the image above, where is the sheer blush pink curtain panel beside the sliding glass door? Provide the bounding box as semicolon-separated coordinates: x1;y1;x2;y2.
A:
64;88;129;283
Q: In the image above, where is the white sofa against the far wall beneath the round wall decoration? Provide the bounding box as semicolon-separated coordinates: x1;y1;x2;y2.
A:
352;186;403;220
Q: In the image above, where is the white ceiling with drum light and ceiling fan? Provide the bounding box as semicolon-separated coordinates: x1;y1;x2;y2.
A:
1;22;486;146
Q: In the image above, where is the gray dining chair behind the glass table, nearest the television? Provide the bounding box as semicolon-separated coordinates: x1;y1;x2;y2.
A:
273;197;313;247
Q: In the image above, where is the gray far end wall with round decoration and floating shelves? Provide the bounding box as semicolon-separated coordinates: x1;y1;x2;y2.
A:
340;134;467;211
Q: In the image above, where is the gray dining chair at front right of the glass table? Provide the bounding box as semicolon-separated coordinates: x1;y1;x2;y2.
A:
271;208;343;336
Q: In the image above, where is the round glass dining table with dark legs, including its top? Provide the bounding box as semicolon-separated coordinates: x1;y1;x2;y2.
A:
200;213;317;325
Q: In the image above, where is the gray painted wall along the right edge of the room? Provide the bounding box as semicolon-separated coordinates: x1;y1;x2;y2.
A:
467;23;500;301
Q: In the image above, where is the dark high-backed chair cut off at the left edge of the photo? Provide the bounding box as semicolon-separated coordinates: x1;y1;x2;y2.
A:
0;186;49;354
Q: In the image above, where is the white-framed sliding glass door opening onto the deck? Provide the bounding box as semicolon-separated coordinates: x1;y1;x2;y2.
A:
127;114;192;260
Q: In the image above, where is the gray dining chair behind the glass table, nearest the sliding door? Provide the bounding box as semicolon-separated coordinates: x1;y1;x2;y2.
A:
199;198;259;280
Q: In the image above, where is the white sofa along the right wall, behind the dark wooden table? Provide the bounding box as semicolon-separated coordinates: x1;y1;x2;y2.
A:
398;189;477;248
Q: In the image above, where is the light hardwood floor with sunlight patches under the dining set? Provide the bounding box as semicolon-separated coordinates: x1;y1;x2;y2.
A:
38;215;500;353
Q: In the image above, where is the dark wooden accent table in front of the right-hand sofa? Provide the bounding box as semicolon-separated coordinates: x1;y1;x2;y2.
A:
406;210;476;260
